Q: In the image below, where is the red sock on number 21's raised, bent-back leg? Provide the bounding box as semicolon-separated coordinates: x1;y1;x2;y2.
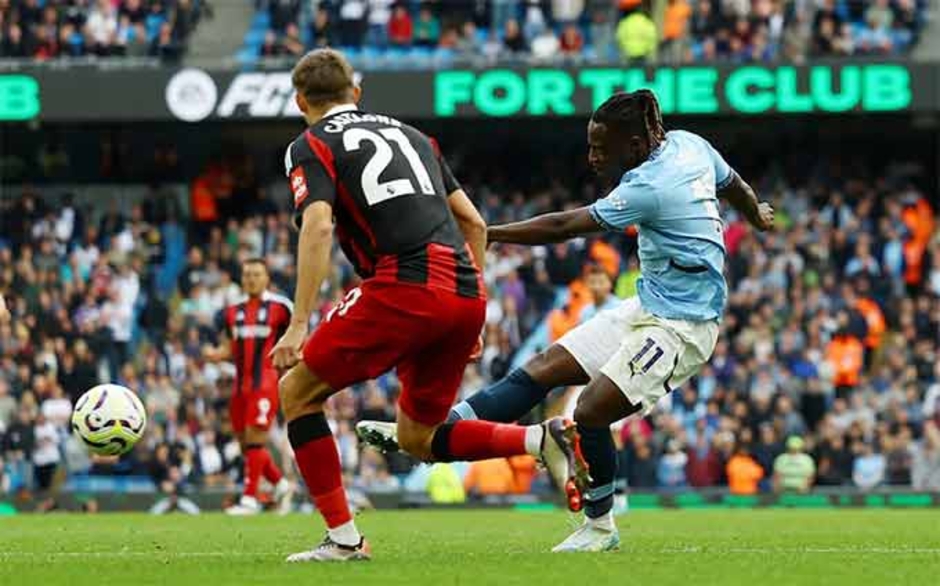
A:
434;420;526;461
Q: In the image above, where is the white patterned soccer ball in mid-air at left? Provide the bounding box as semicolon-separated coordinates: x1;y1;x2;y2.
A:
72;384;147;456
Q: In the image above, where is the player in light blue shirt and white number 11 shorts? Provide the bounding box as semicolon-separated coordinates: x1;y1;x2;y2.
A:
360;90;773;551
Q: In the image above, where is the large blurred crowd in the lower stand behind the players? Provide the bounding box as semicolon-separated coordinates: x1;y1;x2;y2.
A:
0;146;940;502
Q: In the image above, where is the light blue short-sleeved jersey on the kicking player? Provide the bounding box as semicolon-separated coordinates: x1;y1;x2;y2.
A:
590;130;734;321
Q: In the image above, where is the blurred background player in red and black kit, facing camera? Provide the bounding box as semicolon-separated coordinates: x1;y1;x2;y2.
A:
204;258;293;515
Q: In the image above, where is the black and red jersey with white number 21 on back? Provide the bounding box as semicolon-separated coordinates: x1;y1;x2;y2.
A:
284;105;484;297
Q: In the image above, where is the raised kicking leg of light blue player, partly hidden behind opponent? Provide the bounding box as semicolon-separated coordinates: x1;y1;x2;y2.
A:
356;344;589;452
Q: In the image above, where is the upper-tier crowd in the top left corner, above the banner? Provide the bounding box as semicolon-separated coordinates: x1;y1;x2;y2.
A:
0;0;211;61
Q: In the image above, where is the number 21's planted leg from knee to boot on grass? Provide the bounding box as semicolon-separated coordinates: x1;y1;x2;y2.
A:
280;362;371;562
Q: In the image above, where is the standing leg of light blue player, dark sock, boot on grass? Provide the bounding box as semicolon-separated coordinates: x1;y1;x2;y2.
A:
552;374;639;552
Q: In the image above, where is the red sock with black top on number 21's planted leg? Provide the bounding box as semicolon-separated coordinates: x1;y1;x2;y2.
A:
287;413;352;529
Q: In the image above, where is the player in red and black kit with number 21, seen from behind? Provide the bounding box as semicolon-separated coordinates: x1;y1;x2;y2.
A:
273;49;587;562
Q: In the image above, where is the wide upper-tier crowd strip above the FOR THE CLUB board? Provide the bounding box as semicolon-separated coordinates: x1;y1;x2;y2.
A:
252;0;926;64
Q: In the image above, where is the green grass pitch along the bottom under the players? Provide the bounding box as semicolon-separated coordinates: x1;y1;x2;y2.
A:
0;510;940;586
